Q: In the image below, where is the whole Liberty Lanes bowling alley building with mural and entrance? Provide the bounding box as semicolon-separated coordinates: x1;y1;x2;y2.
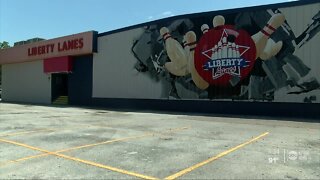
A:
0;0;320;118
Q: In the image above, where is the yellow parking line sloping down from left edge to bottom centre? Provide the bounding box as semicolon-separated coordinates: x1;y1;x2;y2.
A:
0;139;157;179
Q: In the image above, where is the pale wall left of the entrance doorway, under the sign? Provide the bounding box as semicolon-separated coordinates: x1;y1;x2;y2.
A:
2;60;51;104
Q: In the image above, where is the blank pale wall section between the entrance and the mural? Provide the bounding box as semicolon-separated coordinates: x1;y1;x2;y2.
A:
93;29;162;99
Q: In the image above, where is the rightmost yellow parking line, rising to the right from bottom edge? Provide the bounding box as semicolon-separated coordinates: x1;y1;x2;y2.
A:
165;132;269;179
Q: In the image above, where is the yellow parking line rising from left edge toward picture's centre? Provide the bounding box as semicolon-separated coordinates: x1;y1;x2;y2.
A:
0;127;190;166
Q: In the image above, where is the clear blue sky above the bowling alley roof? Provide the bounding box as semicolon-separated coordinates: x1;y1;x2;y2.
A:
0;0;296;45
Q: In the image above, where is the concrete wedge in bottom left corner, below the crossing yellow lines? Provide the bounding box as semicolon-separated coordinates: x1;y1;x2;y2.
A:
0;156;139;179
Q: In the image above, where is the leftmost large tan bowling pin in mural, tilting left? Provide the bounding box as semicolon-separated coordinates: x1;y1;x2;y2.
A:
160;27;187;76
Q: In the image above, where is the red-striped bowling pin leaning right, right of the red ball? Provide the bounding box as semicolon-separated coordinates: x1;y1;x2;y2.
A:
251;13;285;59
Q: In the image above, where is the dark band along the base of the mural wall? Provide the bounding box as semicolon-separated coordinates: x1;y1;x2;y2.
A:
92;98;320;121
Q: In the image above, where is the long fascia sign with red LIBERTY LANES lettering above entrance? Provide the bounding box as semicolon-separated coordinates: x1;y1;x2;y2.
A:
0;31;97;64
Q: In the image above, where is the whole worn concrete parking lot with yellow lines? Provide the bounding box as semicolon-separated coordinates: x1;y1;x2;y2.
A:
0;103;320;179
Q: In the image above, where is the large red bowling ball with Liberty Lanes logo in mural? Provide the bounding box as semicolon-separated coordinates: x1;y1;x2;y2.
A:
194;25;256;86
